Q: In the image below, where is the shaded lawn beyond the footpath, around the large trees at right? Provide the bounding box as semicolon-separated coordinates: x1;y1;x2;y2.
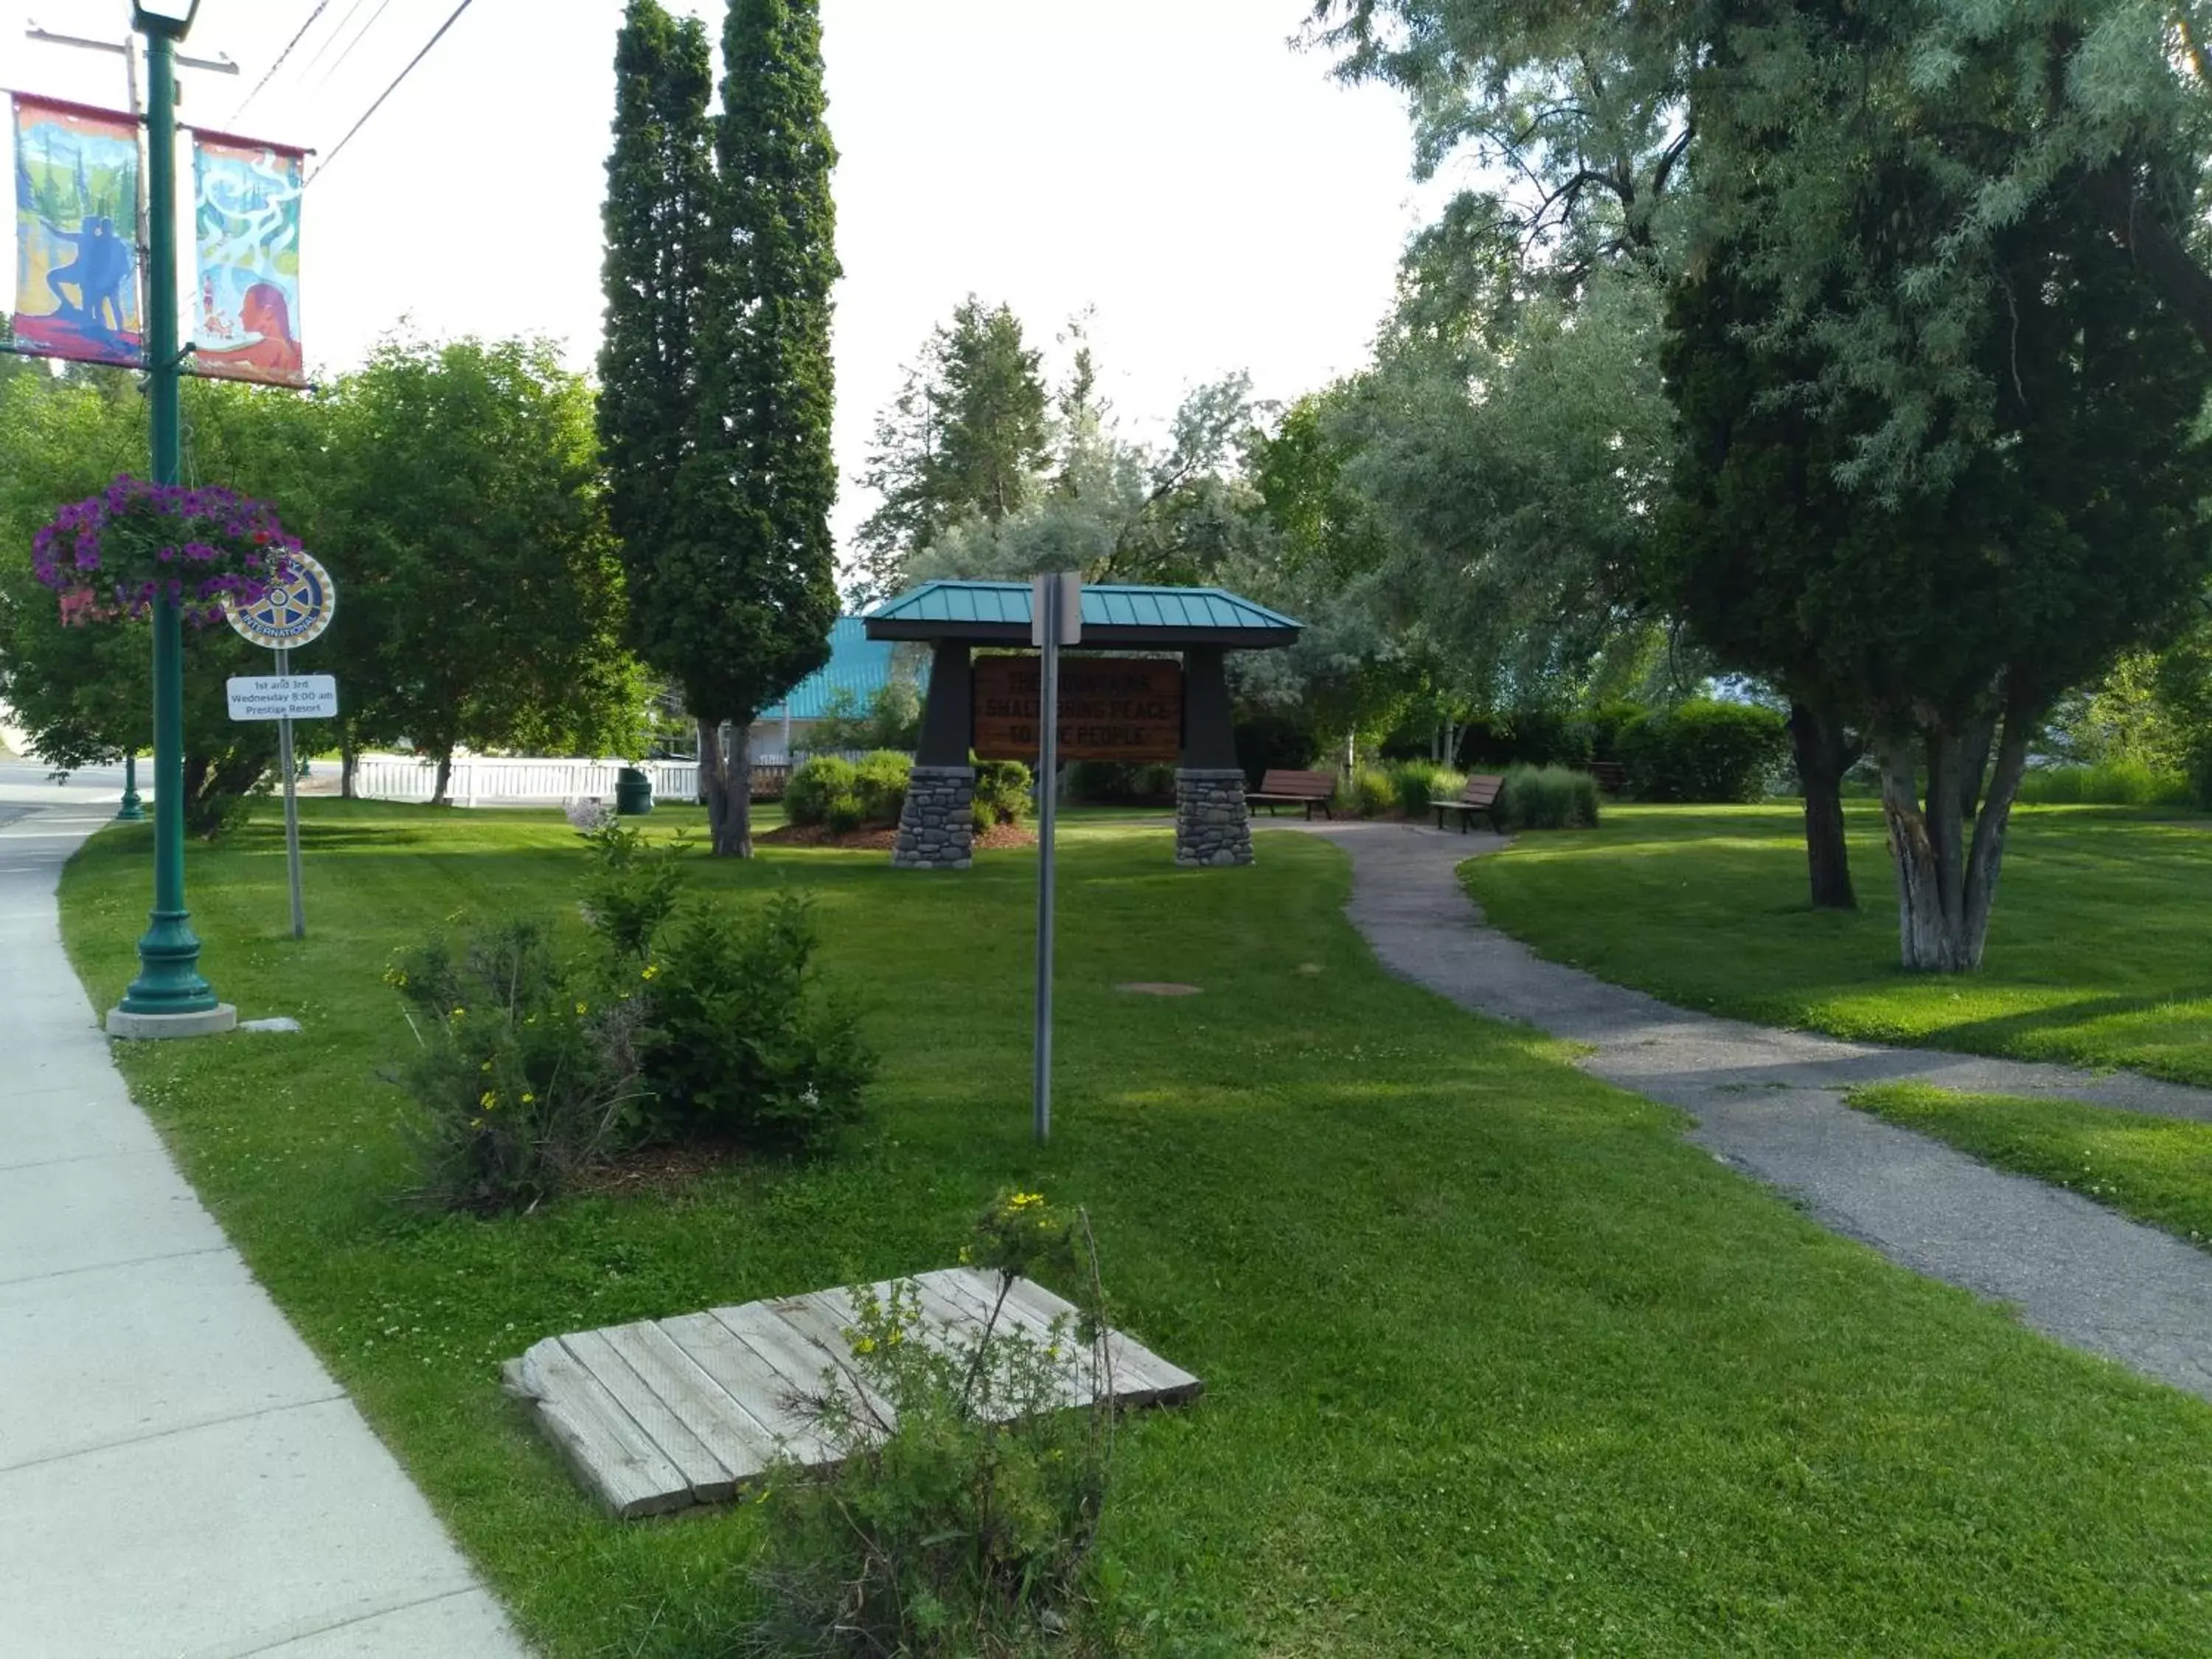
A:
1462;801;2212;1084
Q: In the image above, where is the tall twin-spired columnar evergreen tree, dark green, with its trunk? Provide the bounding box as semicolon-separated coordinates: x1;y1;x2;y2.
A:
604;0;838;858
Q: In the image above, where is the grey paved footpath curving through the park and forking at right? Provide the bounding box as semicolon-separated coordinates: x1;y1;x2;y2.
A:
1298;823;2212;1398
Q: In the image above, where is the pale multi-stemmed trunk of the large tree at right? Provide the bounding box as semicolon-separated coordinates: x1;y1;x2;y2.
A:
1878;710;2033;973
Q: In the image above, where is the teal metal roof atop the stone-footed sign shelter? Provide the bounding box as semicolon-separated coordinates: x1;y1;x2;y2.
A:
867;582;1303;648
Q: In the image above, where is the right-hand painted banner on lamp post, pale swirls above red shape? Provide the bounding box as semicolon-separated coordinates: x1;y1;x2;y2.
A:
188;133;307;385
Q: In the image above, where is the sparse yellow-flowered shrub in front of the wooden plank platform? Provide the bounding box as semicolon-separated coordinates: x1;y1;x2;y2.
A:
754;1192;1117;1659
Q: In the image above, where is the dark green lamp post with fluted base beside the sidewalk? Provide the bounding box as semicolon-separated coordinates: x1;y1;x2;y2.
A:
108;0;239;1037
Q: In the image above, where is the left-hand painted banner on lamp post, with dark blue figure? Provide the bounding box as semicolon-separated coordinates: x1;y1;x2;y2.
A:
13;95;146;367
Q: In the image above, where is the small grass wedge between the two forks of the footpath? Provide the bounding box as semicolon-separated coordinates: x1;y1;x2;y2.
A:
1851;1084;2212;1245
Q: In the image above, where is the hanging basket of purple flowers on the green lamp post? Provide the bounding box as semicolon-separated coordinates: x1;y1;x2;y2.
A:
31;484;299;628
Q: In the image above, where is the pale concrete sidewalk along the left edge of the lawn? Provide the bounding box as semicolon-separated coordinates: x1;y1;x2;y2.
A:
0;796;526;1659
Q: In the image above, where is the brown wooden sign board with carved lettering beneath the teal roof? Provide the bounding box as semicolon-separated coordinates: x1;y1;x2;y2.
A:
973;657;1183;763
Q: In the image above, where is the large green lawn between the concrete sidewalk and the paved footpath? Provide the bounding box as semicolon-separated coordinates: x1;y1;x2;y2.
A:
64;801;2212;1659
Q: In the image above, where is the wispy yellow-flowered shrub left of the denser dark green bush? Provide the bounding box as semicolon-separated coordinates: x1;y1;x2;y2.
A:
385;922;646;1214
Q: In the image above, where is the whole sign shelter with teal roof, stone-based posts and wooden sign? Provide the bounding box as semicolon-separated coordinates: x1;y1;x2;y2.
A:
867;582;1301;869
